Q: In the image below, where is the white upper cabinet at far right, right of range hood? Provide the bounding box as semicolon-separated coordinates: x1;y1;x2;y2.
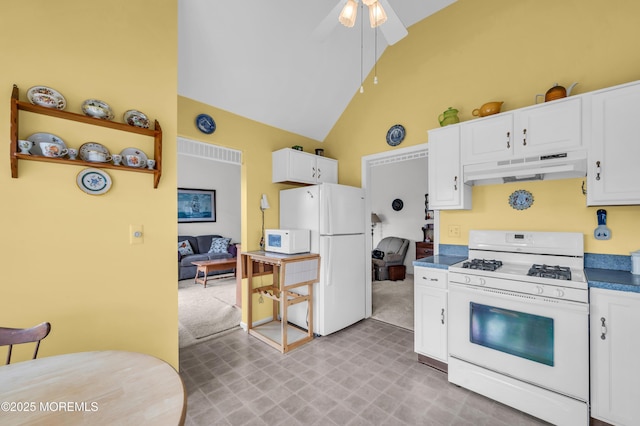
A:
587;82;640;206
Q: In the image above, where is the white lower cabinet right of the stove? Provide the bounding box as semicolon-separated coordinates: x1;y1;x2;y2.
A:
590;288;640;426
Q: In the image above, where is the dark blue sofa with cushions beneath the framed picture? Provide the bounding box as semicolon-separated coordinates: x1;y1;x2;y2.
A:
178;235;237;280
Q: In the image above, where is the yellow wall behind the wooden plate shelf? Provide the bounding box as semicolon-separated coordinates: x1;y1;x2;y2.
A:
0;0;178;368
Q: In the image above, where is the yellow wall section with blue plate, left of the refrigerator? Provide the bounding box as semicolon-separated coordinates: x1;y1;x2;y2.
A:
178;96;320;323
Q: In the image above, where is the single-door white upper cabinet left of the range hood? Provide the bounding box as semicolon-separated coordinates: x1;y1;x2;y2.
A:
428;126;471;210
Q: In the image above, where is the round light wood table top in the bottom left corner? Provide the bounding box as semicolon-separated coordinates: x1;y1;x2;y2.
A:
0;351;187;425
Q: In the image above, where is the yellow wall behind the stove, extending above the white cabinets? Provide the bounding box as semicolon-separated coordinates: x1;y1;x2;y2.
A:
325;0;640;255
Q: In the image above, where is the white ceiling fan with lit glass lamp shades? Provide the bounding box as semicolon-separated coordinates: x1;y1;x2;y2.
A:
313;0;409;45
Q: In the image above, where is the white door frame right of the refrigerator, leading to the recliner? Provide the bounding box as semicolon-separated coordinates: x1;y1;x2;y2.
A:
361;143;439;318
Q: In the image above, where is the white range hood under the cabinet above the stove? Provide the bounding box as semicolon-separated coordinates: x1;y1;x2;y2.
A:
463;150;587;185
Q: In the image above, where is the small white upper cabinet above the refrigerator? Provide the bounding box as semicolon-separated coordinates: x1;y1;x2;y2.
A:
271;148;338;184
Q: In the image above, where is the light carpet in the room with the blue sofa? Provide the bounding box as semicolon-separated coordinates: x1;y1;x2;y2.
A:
178;277;242;348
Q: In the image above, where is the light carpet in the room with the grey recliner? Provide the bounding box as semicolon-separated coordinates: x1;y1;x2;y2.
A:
371;275;413;330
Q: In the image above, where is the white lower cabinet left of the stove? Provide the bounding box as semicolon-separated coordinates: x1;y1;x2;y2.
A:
414;266;448;364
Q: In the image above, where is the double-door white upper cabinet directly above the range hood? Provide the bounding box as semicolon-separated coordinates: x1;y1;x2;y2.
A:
461;97;582;165
